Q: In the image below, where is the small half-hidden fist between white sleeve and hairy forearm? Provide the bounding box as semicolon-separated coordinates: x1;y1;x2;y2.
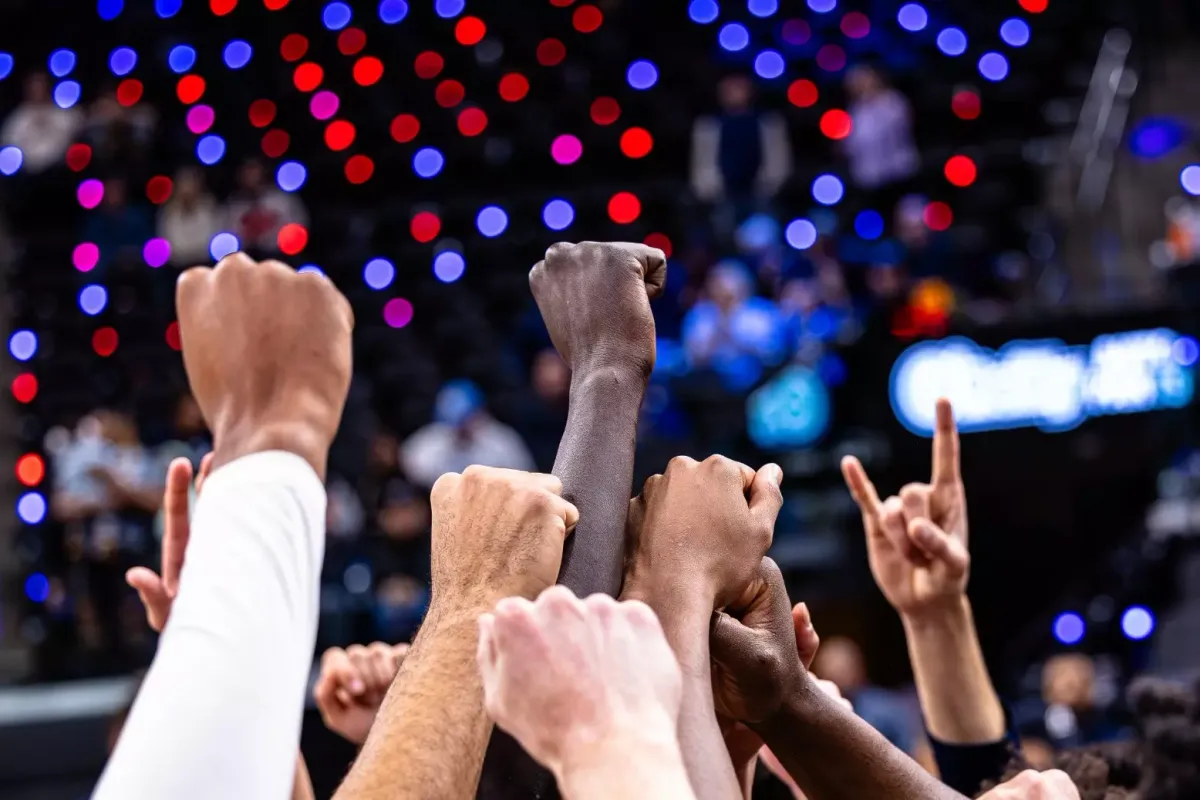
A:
312;642;408;745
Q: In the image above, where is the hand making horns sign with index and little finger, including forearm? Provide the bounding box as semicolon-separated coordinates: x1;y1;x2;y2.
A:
842;399;1004;745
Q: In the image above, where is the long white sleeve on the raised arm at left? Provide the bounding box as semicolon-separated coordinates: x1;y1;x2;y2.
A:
92;452;325;800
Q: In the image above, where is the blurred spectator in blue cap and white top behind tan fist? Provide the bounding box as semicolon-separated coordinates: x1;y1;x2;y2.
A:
400;380;534;488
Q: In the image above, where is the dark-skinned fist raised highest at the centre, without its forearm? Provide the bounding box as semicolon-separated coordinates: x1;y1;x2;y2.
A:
529;242;667;379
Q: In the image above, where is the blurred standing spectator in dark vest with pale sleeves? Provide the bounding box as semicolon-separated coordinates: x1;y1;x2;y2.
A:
691;73;792;235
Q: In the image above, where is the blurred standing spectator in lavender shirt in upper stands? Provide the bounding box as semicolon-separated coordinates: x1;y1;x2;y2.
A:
842;65;920;219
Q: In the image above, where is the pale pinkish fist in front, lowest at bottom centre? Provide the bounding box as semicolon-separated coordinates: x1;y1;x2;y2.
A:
479;587;683;778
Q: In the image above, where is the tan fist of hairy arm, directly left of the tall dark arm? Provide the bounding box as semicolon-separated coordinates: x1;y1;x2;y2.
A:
431;467;580;609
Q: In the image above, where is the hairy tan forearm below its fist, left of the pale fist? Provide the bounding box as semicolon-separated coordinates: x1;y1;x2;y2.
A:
335;604;492;800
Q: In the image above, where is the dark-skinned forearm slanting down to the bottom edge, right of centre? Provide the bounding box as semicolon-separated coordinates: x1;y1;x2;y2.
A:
752;676;962;800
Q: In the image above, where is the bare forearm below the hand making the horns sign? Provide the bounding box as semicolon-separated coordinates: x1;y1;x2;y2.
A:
902;597;1004;745
